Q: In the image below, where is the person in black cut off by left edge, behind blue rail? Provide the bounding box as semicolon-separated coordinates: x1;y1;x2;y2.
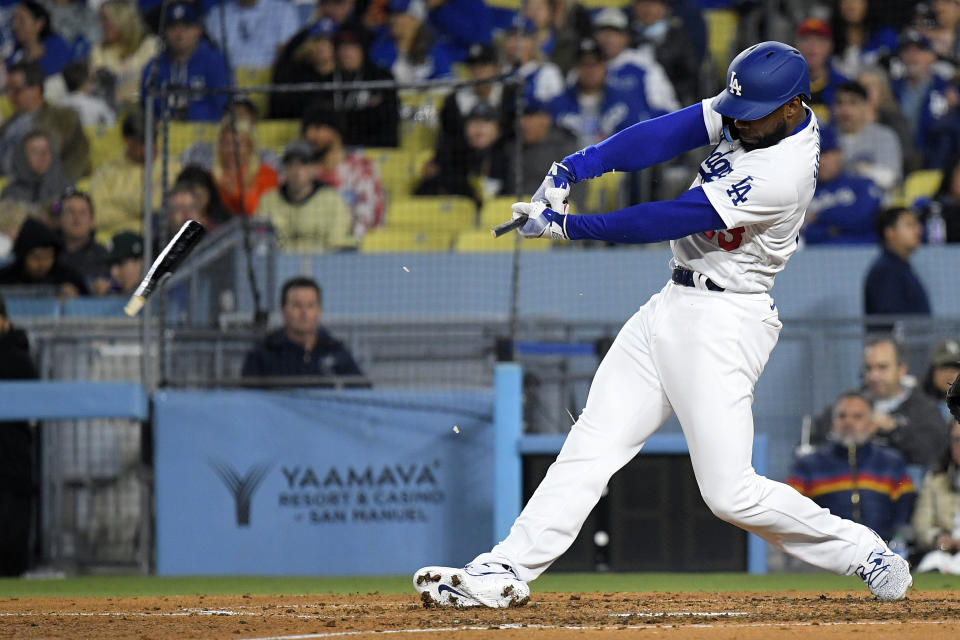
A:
0;296;38;576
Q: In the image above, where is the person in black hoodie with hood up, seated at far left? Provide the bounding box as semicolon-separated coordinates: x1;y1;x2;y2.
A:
0;218;88;298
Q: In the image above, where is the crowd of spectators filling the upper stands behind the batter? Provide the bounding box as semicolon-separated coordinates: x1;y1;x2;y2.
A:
0;0;960;296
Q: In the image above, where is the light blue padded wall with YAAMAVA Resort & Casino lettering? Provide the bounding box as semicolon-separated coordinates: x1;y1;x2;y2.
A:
154;389;493;575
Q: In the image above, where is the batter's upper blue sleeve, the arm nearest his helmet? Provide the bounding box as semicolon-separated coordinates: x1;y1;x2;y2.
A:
563;102;710;181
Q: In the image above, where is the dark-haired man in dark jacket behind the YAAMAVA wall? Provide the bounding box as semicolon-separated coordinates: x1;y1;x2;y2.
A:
243;277;363;377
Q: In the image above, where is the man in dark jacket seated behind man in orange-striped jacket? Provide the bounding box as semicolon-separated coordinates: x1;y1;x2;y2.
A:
811;336;947;467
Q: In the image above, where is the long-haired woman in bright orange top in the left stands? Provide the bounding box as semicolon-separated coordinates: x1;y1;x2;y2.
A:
213;116;279;216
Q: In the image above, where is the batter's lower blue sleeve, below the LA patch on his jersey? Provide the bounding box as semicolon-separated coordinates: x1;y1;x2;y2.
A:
565;187;727;244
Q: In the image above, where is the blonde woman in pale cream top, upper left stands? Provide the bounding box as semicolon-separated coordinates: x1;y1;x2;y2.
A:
90;0;160;109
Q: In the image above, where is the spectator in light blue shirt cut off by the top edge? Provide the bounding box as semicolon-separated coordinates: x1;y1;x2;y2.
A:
204;0;300;70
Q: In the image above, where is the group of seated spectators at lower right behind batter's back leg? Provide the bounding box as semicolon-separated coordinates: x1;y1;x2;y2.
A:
787;334;960;573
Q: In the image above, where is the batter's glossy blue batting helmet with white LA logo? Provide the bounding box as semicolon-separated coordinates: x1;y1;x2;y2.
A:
711;41;810;120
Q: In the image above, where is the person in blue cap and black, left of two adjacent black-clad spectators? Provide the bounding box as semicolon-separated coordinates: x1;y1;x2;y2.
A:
269;18;338;119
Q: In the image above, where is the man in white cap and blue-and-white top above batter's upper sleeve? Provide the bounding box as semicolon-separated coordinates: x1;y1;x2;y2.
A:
593;8;680;118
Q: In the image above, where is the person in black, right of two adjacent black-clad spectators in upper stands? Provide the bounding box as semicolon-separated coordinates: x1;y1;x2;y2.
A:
324;27;400;147
